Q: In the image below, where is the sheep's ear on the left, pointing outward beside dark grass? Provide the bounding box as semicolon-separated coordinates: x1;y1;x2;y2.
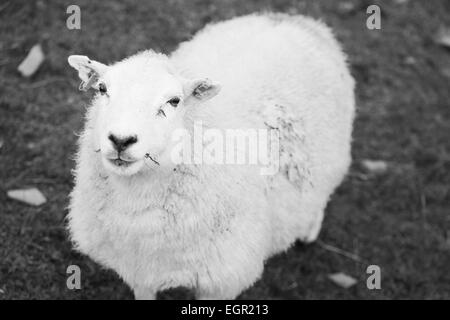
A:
67;56;108;91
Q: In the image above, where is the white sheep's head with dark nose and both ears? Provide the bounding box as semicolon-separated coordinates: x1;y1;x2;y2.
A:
68;52;220;176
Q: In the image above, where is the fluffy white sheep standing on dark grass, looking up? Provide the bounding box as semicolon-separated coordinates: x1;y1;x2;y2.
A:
68;14;355;299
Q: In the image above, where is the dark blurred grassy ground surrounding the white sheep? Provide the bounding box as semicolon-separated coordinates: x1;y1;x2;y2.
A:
0;0;450;299
